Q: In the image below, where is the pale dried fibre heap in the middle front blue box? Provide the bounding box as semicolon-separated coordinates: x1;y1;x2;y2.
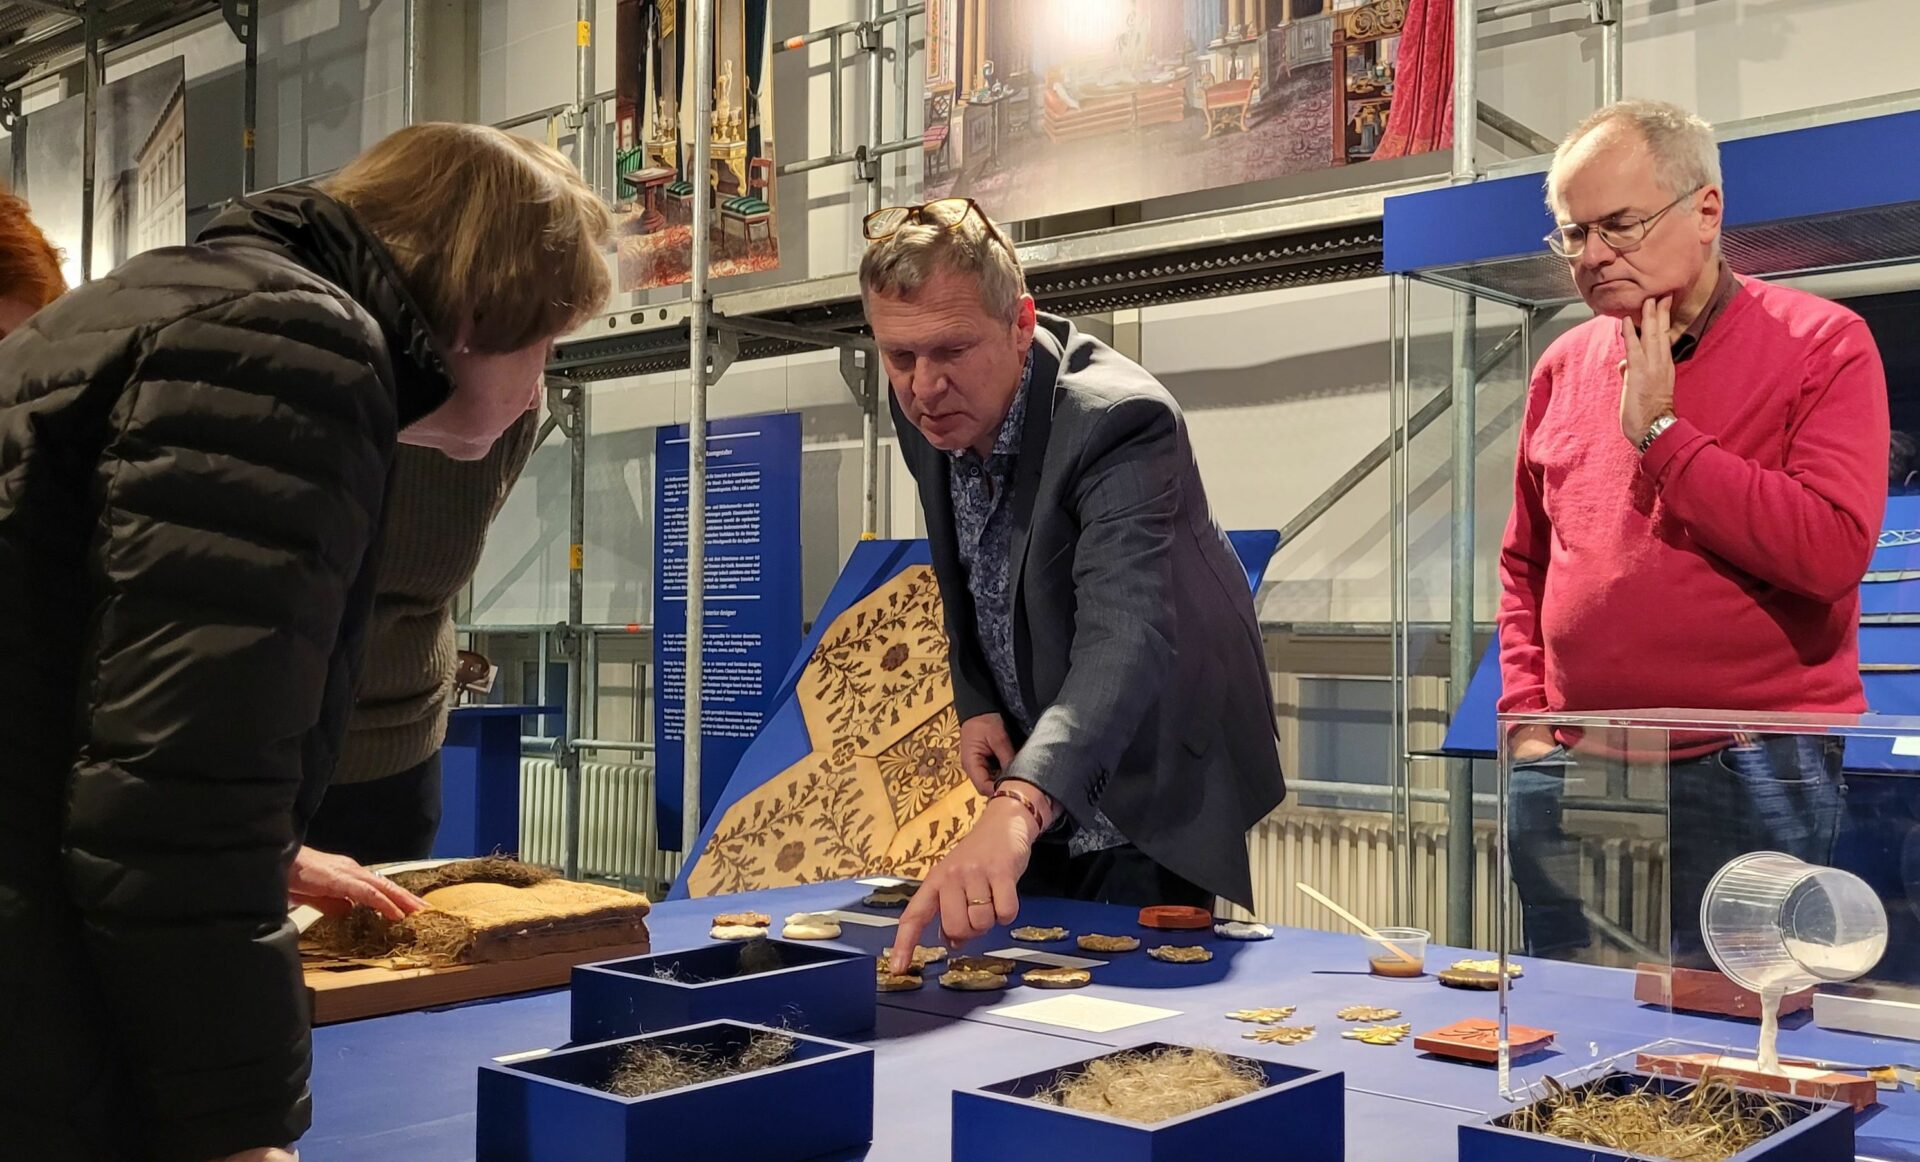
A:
1035;1049;1267;1124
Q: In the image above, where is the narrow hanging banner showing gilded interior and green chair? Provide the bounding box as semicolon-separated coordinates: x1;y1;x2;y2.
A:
614;0;780;290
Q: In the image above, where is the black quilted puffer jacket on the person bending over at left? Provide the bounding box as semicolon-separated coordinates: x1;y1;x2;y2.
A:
0;188;449;1162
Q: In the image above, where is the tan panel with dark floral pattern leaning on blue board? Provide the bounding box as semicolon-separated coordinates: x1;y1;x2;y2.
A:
687;565;983;895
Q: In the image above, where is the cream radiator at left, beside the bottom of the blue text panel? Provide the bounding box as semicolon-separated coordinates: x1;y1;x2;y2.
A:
520;759;680;893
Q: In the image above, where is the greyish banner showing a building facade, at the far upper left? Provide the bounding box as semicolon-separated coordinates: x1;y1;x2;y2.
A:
17;58;186;286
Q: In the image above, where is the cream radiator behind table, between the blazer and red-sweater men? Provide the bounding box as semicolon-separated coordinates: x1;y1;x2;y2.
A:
1227;805;1667;951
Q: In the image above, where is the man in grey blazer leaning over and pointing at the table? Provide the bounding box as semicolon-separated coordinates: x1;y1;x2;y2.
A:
875;198;1286;962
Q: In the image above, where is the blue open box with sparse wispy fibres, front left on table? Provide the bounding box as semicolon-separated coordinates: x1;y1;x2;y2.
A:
474;1022;874;1162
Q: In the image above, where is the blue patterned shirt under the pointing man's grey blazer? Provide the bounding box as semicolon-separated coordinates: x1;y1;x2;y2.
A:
947;351;1127;855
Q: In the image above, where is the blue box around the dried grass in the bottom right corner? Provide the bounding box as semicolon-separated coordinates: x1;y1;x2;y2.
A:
1459;1070;1853;1162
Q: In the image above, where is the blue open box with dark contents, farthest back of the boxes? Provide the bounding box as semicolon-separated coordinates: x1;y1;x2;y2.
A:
572;939;874;1041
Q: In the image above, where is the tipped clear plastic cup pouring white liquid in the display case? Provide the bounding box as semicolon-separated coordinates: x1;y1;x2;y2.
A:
1699;851;1887;993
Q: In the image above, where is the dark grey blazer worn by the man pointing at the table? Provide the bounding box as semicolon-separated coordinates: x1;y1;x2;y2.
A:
889;315;1286;905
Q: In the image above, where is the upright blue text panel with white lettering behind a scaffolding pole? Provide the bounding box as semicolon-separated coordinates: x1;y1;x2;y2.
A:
653;411;801;851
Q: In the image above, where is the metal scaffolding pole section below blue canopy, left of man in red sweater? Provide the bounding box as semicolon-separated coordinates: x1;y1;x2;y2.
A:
1446;294;1480;949
